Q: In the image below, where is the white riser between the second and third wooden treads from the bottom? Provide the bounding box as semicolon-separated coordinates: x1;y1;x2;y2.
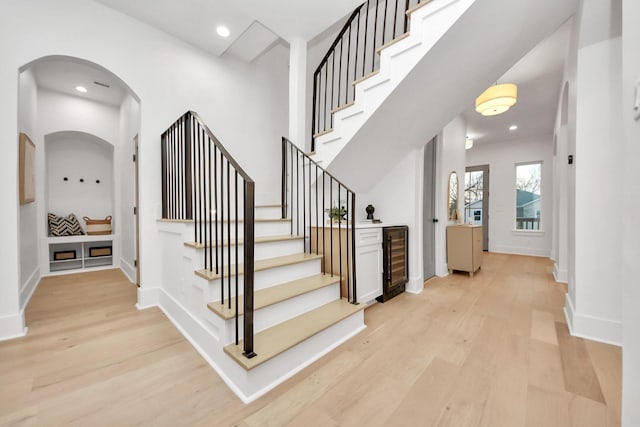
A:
196;258;321;301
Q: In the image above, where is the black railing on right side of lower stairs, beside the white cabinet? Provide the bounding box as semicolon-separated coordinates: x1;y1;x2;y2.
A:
281;137;358;304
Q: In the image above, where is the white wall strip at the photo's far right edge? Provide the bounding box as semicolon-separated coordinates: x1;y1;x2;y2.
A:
619;0;640;427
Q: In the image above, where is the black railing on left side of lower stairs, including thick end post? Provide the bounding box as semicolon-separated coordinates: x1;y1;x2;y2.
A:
161;111;255;358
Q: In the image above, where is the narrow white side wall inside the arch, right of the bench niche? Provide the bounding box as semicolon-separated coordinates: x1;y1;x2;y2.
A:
120;95;140;281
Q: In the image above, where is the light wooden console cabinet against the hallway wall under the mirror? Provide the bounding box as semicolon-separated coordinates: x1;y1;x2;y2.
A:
447;224;482;277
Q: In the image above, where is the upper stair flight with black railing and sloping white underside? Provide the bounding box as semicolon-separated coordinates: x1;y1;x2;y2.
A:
312;0;578;191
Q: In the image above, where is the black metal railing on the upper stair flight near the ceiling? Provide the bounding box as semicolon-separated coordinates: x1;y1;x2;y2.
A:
311;0;430;151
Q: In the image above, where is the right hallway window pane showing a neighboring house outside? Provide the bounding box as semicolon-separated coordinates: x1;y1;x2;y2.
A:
516;162;542;230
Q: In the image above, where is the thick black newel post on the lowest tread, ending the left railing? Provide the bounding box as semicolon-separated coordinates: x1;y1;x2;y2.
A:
244;181;256;359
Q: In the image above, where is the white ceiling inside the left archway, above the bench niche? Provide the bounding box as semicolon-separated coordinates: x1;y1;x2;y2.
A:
30;58;127;107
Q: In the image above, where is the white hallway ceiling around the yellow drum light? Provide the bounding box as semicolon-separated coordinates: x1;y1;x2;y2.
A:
463;21;571;144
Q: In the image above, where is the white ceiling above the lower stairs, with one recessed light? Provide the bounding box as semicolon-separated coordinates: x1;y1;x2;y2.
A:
96;0;362;58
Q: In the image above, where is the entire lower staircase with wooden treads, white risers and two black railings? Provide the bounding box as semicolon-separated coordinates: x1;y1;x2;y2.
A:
153;112;365;402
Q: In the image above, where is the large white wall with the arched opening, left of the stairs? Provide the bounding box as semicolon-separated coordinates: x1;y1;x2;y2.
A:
0;0;288;340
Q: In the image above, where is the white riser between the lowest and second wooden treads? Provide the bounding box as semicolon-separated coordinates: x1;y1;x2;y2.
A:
219;283;340;345
